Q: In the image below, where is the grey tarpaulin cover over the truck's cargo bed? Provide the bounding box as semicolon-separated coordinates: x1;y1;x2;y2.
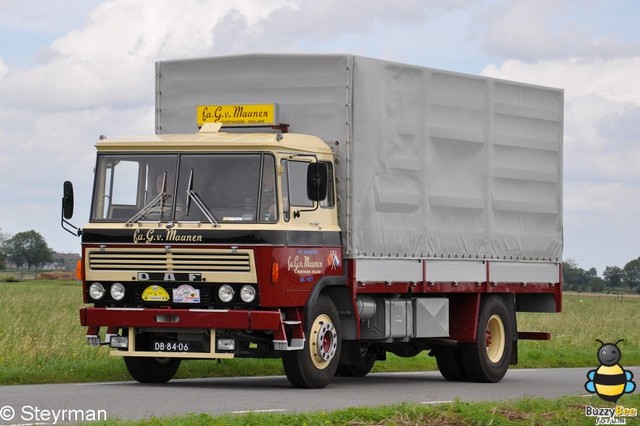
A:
156;54;564;260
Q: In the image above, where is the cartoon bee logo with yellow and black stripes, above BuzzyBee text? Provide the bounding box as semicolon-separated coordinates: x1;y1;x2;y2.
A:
584;339;636;403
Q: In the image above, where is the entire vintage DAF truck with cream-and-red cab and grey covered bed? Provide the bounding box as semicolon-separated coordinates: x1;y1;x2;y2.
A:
61;54;564;388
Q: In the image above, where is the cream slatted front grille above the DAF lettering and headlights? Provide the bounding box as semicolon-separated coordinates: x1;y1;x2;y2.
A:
88;249;251;272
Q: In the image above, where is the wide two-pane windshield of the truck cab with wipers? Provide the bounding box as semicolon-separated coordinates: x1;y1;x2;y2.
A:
91;154;278;225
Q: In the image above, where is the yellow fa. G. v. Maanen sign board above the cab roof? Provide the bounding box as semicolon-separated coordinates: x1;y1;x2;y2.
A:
196;104;278;126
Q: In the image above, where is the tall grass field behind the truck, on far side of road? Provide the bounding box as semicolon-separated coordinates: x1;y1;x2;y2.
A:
0;281;640;385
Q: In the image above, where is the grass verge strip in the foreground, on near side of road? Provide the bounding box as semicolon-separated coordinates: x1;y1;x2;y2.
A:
90;394;640;426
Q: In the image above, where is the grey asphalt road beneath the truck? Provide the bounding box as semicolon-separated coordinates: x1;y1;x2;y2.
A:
0;367;608;424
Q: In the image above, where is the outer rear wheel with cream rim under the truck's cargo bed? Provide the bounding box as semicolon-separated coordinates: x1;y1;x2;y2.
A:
461;296;513;383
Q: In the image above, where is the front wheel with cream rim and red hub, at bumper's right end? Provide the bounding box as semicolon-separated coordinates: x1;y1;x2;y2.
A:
282;296;342;389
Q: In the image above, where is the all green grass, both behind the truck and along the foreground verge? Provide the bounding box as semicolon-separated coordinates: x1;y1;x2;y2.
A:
0;281;640;426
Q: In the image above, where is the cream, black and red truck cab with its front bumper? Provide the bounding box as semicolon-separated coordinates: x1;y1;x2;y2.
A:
66;125;342;382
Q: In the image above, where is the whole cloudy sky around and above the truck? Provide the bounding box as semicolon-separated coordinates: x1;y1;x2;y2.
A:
0;0;640;274
